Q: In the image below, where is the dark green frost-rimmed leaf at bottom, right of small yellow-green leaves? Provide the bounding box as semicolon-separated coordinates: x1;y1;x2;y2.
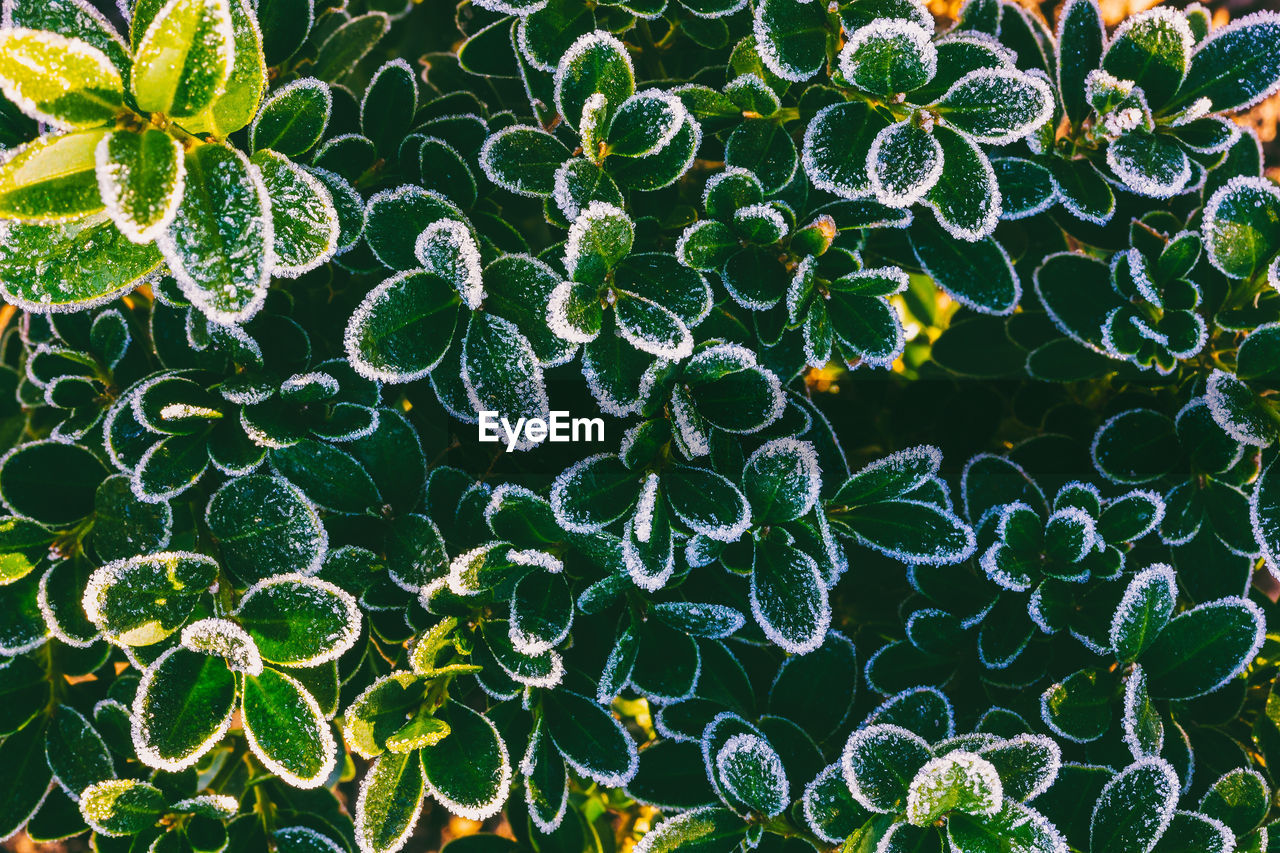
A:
419;701;511;821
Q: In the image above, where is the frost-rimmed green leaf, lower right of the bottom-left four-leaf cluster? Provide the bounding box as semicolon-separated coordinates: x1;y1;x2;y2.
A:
241;666;338;788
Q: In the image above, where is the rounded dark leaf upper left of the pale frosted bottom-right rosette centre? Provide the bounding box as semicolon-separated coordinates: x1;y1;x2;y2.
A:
840;724;932;815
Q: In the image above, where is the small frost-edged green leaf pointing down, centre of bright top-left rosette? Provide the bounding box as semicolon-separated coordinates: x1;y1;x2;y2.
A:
96;129;186;243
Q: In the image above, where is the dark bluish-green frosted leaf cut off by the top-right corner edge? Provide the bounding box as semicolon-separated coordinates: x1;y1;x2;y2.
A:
1167;12;1280;113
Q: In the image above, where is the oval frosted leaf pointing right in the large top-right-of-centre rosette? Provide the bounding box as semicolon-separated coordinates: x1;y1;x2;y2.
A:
933;68;1053;145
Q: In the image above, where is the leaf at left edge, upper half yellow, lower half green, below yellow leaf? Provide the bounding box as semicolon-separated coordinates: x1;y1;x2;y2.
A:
0;128;108;223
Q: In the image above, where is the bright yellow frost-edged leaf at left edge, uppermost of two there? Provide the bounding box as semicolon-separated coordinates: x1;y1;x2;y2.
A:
0;28;124;129
